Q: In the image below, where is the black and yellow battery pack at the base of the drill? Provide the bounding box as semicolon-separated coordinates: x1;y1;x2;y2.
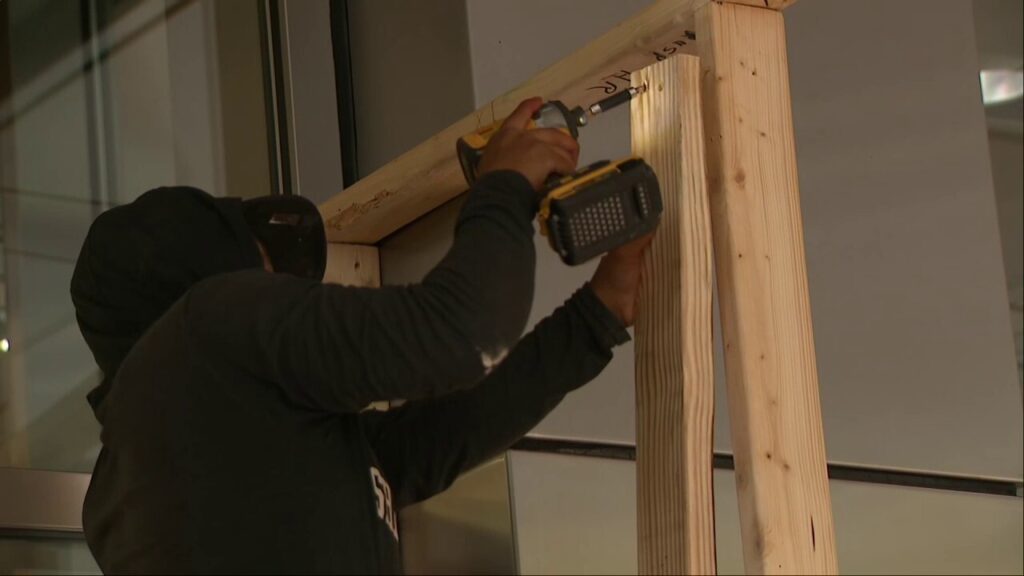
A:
538;157;662;265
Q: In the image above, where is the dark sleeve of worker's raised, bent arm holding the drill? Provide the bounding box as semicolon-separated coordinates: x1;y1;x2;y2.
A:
184;171;537;412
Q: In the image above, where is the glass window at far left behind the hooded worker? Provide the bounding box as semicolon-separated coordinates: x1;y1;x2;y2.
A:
0;0;273;471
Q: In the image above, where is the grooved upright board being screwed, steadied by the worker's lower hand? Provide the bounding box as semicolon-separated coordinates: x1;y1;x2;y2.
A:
632;55;716;574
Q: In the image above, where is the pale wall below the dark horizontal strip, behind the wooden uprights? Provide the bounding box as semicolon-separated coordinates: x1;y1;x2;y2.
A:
509;452;1024;574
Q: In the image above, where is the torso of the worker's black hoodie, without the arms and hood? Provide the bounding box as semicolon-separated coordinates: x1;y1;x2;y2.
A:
84;272;400;573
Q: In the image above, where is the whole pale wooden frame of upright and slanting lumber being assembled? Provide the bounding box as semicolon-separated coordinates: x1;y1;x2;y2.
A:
321;0;838;573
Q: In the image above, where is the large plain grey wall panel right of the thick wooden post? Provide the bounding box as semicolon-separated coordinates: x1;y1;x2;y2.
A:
787;0;1022;479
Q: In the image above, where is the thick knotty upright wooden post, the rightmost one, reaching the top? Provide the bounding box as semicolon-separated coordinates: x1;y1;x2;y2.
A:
696;3;838;574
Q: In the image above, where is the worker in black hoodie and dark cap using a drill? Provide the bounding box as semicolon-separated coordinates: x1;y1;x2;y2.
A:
71;98;645;574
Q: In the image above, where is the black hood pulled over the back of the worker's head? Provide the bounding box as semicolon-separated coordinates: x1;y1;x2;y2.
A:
71;187;260;408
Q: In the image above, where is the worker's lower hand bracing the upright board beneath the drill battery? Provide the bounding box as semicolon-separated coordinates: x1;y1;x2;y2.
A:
590;233;654;326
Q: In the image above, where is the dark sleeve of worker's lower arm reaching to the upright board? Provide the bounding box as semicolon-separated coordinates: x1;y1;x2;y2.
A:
366;286;629;505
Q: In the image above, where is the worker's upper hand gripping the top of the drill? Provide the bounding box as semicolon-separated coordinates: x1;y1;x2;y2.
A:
479;98;580;191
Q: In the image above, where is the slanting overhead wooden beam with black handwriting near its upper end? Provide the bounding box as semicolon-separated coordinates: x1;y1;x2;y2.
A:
321;0;707;244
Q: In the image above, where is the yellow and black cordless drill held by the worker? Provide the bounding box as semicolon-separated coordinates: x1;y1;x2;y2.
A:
456;87;662;265
